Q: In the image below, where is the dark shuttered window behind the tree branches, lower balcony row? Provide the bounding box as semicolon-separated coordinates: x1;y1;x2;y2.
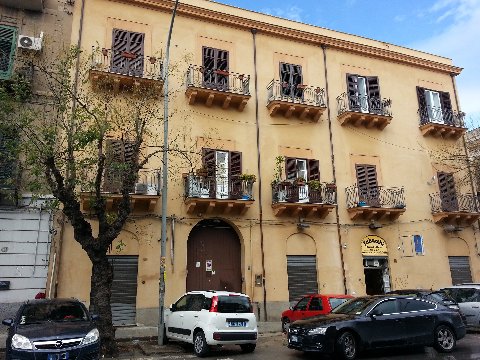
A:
103;140;134;192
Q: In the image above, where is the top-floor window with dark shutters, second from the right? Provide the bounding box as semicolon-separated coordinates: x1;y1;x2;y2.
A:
347;74;382;113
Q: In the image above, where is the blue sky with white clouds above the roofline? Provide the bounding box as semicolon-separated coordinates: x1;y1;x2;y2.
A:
216;0;480;127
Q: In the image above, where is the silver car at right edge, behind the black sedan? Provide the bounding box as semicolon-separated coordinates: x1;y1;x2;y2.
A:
442;283;480;330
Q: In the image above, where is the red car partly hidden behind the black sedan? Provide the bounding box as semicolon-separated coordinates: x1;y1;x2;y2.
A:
282;294;353;332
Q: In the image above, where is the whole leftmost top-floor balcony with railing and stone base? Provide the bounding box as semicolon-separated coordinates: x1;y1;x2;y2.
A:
89;47;163;95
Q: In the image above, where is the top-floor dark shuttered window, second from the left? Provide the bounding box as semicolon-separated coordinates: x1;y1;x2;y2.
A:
202;46;229;91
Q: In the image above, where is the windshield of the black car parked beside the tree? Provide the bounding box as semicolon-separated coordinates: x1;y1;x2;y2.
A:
19;302;88;325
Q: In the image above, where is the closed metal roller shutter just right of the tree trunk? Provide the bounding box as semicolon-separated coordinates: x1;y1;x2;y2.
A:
108;255;138;326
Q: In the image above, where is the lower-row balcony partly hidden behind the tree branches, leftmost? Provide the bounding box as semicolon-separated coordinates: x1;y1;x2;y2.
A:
80;169;160;213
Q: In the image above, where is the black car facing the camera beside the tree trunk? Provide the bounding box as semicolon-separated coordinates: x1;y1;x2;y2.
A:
2;299;100;360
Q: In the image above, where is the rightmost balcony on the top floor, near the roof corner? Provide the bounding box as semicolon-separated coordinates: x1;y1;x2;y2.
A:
418;106;467;140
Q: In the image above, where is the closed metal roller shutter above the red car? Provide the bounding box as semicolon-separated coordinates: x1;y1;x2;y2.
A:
287;255;318;302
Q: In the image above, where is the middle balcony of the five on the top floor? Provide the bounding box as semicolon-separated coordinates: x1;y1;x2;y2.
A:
267;80;327;121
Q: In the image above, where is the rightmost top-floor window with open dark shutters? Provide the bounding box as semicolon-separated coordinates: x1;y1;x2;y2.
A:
417;86;454;125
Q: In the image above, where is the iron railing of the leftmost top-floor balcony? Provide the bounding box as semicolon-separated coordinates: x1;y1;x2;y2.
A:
91;46;163;80
